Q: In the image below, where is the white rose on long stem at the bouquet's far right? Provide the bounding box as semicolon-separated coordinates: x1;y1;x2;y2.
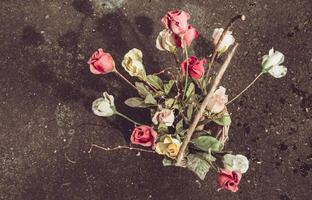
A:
261;48;287;78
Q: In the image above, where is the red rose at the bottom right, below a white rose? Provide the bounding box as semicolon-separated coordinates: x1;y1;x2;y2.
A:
218;169;242;192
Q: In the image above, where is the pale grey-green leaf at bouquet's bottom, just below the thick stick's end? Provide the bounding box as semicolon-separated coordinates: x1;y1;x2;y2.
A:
186;154;210;180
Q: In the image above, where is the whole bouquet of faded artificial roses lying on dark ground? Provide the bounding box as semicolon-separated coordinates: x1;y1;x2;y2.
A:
88;10;287;192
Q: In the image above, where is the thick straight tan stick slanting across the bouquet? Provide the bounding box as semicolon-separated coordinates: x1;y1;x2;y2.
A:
176;43;238;166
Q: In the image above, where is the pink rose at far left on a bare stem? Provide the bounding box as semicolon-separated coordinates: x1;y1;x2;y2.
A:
88;49;115;74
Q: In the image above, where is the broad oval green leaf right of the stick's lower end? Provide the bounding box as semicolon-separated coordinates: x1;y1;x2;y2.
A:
191;136;222;152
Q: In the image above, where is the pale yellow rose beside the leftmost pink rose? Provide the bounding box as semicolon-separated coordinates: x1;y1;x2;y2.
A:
122;48;146;79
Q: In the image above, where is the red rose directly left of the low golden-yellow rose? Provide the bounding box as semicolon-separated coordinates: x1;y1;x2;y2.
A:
130;125;157;147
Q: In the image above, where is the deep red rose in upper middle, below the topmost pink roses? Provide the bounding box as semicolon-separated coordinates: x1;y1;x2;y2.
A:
181;56;206;79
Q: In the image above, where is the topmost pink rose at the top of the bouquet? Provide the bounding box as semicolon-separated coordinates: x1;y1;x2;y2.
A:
161;10;190;35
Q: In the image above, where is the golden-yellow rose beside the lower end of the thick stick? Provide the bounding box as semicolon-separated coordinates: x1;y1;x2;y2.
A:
155;135;181;159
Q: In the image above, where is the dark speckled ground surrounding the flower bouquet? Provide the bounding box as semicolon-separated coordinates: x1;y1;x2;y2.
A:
0;0;312;200
